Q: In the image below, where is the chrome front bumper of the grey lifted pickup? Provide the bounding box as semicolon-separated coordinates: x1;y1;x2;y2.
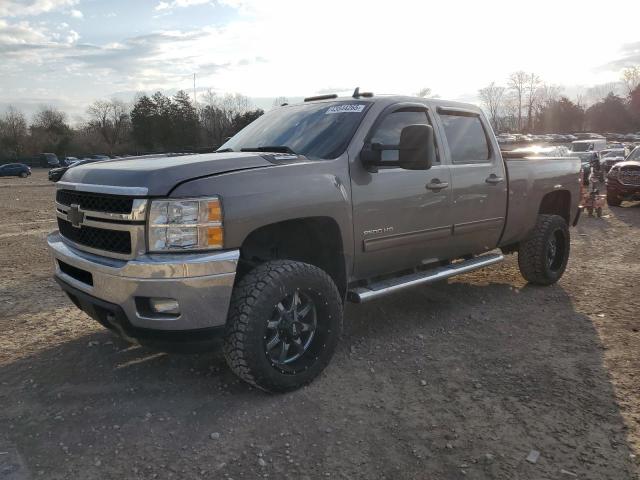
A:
47;232;240;332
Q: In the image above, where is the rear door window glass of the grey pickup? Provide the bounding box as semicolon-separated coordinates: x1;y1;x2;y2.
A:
440;114;491;163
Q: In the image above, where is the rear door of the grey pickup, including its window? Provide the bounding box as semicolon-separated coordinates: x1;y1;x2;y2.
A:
438;107;508;255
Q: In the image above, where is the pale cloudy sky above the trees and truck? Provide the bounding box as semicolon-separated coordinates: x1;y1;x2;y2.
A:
0;0;640;121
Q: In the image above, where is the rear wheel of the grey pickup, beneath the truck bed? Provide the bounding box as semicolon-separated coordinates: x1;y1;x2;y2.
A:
518;215;570;285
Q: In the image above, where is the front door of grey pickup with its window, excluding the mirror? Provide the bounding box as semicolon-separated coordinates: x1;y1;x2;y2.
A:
351;104;452;278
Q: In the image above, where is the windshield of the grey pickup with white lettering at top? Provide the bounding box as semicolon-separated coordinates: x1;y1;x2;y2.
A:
218;101;370;160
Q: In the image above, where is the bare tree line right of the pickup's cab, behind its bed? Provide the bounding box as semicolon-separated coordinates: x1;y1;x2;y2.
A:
478;66;640;133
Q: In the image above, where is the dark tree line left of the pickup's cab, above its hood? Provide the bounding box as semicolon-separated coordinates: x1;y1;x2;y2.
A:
0;90;264;159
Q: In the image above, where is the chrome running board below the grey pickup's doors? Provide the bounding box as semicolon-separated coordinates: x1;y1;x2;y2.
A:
347;253;504;303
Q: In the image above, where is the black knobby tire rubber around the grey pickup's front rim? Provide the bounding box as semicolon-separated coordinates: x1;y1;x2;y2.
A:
223;260;343;392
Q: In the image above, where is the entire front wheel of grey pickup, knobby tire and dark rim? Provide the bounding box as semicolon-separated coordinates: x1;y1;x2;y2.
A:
224;260;342;392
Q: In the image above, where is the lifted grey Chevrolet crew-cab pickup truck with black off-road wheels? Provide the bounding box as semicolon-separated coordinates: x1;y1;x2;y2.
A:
48;92;580;392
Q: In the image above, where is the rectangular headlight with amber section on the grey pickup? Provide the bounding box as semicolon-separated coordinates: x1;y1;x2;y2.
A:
148;197;224;252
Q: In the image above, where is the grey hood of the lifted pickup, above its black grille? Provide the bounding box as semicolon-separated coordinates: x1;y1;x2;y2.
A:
60;152;282;196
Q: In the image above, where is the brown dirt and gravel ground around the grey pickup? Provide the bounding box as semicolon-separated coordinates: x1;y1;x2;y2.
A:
0;170;640;480
